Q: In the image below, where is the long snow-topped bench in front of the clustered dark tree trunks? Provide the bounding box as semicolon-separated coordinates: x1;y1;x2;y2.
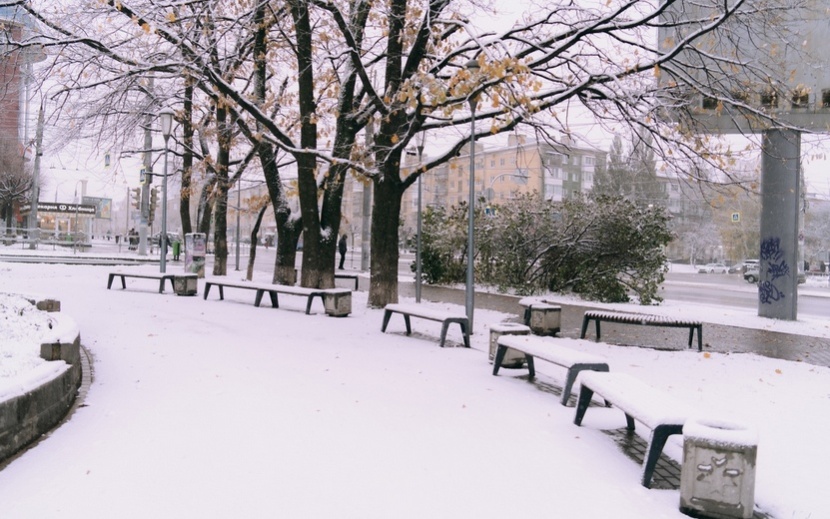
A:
204;278;352;317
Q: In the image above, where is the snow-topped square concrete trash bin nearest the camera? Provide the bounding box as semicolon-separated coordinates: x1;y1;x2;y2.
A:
680;419;758;519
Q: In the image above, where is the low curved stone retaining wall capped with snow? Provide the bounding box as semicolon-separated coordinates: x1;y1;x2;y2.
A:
0;299;82;463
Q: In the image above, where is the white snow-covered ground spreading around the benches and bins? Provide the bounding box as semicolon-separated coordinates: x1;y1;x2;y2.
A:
0;263;830;519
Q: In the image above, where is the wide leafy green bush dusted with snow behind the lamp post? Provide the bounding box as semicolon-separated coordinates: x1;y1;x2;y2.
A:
422;194;672;304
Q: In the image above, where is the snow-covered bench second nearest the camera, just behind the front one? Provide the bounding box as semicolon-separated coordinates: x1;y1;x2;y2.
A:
493;335;608;405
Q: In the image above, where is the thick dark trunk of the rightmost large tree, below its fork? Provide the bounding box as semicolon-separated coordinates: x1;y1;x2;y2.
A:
369;179;403;308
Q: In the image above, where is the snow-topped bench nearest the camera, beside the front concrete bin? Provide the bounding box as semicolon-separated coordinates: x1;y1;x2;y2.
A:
574;372;694;488
